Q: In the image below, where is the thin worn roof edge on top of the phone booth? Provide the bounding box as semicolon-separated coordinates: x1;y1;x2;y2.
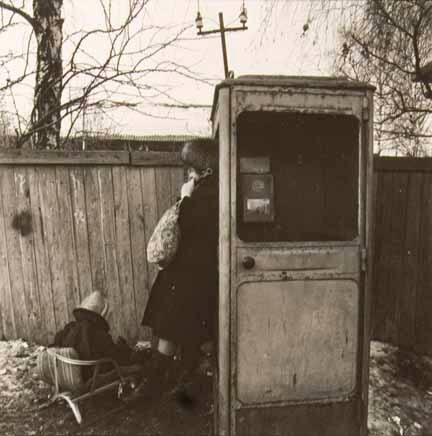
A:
211;75;375;120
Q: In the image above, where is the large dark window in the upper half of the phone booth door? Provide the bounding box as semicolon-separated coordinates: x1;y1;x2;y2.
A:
237;111;359;242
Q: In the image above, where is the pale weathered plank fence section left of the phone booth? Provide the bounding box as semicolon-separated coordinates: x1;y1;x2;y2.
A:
0;151;184;344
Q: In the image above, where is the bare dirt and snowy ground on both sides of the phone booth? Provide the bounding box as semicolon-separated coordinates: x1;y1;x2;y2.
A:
0;341;432;436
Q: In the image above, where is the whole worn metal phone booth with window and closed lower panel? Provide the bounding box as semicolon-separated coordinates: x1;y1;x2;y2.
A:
212;76;373;436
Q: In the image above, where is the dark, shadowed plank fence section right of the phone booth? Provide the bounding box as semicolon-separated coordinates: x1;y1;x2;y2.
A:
372;157;432;354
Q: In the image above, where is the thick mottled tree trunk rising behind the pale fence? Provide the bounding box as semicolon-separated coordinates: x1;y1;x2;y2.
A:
32;0;63;149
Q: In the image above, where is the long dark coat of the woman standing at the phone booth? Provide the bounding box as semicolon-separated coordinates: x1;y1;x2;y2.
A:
142;176;219;347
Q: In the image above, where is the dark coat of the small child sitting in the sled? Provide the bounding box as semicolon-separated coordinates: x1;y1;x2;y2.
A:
52;309;132;380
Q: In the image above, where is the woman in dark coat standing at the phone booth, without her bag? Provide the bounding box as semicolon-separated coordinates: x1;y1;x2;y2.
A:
142;139;219;396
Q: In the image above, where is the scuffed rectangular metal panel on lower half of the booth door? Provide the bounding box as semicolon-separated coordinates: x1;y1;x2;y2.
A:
236;280;359;404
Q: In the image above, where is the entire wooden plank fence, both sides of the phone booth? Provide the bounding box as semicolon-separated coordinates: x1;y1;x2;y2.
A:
0;151;432;354
